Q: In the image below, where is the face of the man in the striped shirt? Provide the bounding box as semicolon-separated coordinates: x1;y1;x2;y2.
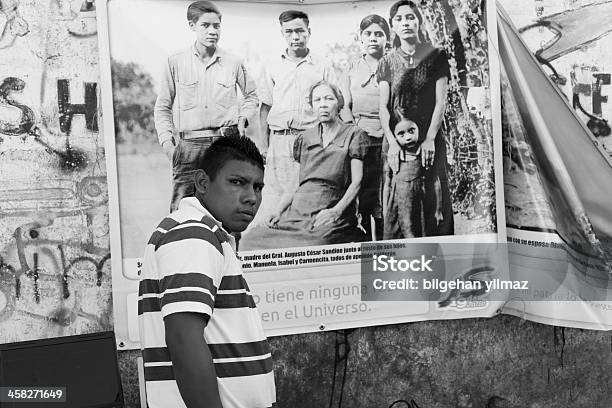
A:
196;160;263;232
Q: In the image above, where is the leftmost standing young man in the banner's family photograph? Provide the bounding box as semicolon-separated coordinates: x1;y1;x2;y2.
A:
154;1;259;211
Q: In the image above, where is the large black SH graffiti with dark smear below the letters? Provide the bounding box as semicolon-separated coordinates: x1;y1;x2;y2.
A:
0;77;98;171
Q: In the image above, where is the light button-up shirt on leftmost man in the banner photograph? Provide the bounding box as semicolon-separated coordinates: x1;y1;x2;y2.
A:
155;45;259;144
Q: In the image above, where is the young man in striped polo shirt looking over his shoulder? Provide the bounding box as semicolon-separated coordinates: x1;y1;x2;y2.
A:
138;136;276;408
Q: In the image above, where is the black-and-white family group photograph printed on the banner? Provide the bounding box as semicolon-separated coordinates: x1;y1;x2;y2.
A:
107;0;501;259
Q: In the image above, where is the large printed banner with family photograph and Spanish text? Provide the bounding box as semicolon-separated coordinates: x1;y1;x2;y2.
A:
99;0;507;347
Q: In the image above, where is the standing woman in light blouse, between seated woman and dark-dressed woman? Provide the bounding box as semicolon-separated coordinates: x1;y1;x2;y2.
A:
341;14;390;240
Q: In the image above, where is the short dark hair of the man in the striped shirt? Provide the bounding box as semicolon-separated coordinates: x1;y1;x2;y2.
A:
198;136;264;181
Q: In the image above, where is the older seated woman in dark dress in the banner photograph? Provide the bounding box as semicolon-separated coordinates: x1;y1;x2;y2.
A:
240;81;368;251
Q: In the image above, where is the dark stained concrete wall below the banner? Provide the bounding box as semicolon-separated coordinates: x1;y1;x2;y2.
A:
119;316;612;408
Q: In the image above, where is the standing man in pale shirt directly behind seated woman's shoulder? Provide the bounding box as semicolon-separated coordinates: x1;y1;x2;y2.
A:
258;10;337;225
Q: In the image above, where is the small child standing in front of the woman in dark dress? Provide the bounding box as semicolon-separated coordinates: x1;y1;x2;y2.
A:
383;114;423;239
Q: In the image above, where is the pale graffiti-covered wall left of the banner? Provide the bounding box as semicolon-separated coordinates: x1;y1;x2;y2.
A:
0;0;112;343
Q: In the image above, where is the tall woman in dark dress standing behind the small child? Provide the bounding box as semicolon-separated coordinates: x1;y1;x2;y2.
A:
378;0;454;236
